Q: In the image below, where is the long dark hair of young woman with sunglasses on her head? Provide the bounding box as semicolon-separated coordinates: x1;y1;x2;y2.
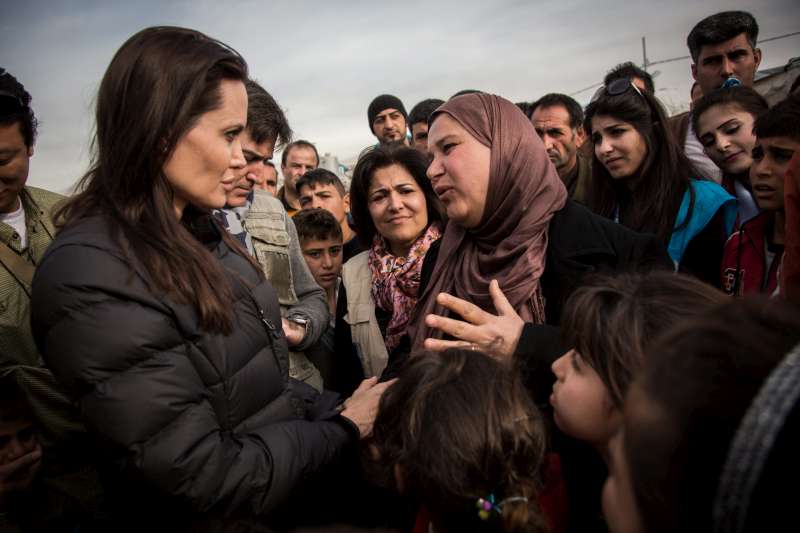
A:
584;87;696;243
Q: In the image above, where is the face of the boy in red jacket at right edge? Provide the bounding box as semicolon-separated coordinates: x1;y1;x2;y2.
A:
750;137;800;211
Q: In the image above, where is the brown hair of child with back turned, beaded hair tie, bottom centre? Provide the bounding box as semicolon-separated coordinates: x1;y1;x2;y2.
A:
365;350;545;532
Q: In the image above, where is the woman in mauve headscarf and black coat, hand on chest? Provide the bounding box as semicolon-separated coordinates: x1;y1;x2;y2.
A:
400;93;670;366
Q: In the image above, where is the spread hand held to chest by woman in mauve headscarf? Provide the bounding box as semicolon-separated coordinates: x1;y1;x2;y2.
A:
424;280;525;362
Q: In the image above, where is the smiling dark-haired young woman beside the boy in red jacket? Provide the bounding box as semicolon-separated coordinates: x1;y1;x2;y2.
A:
692;86;769;224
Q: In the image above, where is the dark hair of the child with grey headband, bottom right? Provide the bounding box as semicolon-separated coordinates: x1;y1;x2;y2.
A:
623;296;800;533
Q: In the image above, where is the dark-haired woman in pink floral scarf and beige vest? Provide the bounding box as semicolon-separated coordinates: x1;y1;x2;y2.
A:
336;146;444;392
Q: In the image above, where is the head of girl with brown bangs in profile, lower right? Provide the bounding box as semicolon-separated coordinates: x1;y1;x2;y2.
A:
550;272;725;458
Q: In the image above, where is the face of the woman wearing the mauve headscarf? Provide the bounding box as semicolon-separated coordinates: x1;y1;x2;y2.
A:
428;113;491;229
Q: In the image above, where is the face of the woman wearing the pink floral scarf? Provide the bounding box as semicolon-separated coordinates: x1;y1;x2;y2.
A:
367;165;428;257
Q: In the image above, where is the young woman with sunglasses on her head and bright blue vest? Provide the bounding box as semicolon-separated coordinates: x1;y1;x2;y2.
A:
585;78;736;286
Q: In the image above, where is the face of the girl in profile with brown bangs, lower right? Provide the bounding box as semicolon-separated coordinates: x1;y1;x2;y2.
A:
550;350;621;450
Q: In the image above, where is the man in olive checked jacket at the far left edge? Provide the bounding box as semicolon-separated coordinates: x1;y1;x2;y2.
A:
0;67;82;443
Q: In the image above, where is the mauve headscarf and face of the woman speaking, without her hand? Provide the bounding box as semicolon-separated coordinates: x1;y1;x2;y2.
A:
416;94;567;341
